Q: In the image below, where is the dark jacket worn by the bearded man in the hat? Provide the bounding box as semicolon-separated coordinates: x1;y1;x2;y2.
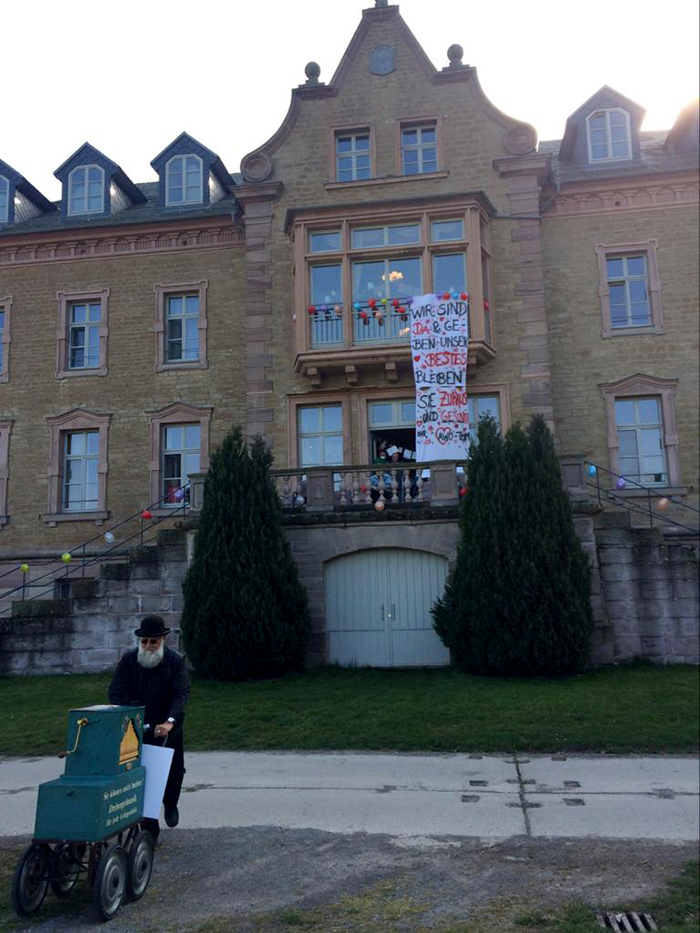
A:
109;645;190;733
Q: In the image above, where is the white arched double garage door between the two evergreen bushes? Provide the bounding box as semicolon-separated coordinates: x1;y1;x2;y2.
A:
325;548;450;667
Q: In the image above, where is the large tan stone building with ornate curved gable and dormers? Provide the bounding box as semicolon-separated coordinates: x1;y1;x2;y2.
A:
0;2;699;663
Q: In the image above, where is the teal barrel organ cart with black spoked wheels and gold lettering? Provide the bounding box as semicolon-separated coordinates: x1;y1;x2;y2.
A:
12;706;154;920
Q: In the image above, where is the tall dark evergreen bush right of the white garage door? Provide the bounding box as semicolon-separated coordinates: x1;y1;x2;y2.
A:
432;415;593;676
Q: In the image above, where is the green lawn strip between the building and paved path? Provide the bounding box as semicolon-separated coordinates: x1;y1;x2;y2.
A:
0;664;699;755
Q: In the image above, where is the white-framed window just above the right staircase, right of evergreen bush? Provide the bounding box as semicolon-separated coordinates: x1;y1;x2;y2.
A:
615;396;667;486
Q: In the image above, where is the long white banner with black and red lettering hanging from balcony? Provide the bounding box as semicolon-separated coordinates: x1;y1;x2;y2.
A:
408;292;469;462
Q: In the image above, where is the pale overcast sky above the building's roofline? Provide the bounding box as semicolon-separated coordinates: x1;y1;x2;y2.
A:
5;0;698;199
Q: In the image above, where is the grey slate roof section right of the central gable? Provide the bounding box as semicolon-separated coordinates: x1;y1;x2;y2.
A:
538;130;698;182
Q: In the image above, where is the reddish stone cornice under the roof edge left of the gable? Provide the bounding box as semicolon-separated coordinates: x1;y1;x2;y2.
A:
0;218;245;268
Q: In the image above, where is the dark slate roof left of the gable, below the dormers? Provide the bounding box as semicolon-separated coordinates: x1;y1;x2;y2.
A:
0;173;243;237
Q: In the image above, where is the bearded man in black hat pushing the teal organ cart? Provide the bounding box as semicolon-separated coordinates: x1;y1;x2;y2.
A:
109;615;190;839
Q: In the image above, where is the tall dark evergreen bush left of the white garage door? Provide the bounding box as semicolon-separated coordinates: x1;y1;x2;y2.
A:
182;428;311;680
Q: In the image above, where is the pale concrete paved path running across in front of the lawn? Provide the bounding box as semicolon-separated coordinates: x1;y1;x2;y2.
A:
0;752;700;845
